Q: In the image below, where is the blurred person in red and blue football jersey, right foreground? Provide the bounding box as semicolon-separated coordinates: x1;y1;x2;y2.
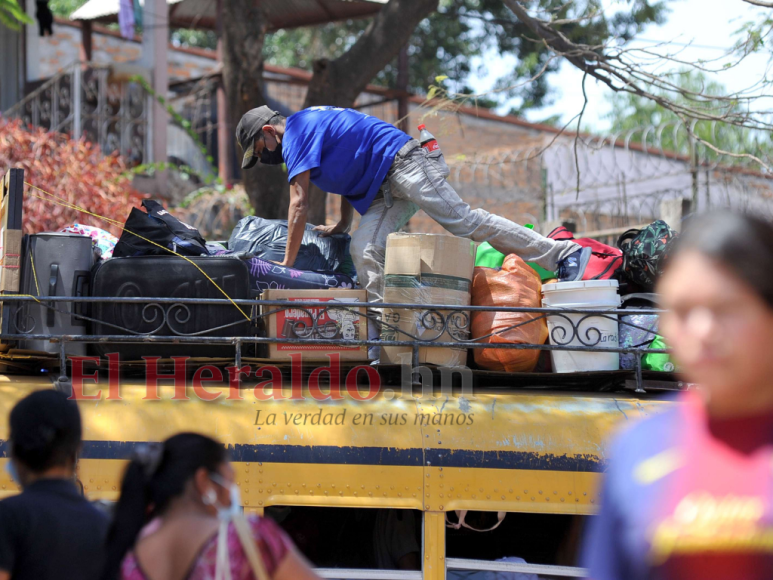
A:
584;213;773;580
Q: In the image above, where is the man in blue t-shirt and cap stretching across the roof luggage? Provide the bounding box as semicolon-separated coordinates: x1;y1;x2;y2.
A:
236;106;591;302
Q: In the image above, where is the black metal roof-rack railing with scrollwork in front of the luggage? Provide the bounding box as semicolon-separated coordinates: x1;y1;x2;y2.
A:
0;295;669;392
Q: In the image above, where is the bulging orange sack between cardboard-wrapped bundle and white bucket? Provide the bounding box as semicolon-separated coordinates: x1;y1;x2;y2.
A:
472;254;548;373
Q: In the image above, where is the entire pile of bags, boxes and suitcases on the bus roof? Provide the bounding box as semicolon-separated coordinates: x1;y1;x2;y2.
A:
9;168;676;373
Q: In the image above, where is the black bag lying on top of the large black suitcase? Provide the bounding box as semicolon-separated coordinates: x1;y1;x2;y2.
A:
113;199;209;258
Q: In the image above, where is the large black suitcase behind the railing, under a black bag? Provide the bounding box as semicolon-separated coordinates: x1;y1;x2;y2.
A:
91;256;254;361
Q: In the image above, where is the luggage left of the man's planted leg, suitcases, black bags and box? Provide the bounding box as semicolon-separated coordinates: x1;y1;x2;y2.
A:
16;200;367;360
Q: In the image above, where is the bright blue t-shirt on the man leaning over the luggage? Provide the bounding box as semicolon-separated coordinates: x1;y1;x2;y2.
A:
282;107;411;214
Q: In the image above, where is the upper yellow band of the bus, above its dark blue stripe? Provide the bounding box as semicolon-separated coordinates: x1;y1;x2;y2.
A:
0;376;669;467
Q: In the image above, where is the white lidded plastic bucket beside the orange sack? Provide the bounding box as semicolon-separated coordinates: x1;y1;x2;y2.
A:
542;280;621;373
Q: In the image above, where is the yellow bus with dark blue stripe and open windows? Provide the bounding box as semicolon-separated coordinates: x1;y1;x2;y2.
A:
0;374;671;580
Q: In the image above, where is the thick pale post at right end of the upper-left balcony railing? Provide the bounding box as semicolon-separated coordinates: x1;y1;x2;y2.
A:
142;0;169;188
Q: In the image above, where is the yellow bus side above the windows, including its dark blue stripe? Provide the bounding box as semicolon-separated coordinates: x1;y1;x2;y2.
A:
0;375;670;513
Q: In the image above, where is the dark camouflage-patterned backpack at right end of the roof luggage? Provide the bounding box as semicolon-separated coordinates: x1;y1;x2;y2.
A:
617;220;677;292
